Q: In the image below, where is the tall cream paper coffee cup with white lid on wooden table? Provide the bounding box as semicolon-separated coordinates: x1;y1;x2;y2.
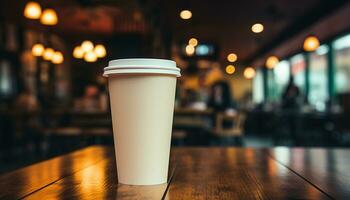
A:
103;59;181;185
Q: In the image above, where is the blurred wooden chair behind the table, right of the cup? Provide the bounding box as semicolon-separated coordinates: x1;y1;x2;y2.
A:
213;112;246;145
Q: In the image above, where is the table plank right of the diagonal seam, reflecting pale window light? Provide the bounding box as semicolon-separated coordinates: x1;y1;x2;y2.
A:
269;147;350;199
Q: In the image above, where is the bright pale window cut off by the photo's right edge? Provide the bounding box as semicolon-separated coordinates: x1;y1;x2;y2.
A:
333;34;350;93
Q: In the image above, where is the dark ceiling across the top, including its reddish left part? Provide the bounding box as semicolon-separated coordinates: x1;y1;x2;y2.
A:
1;0;347;63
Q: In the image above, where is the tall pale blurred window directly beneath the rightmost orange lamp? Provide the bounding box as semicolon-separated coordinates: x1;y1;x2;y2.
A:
308;45;329;111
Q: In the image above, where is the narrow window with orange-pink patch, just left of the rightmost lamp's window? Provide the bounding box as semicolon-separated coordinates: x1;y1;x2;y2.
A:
290;54;306;94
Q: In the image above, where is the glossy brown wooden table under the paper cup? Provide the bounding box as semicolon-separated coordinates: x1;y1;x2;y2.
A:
0;146;350;200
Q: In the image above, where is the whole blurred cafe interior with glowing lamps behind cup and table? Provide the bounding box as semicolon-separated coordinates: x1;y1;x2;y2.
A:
0;0;350;173
